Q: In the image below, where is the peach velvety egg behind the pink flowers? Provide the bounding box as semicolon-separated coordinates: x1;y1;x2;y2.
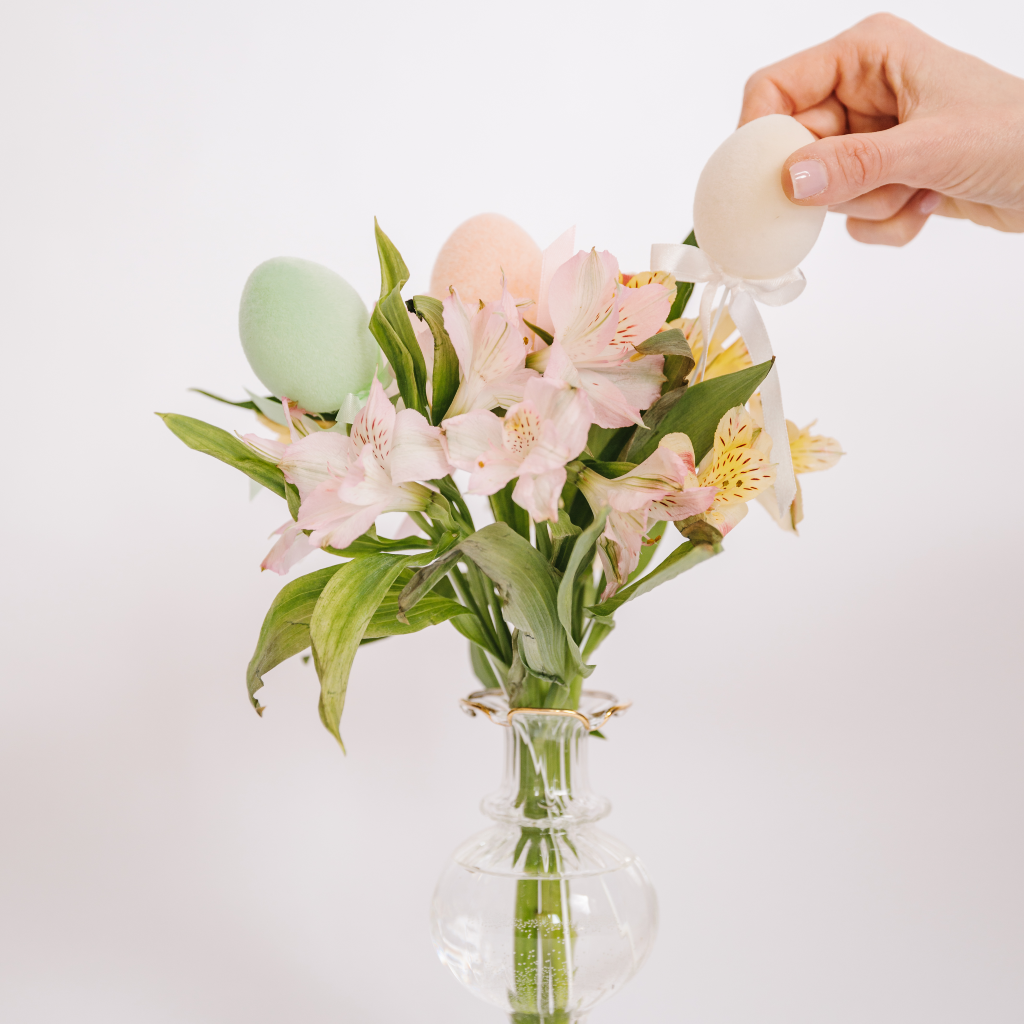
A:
430;213;541;307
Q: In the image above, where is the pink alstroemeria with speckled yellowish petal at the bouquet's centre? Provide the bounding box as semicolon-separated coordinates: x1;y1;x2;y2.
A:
441;376;590;521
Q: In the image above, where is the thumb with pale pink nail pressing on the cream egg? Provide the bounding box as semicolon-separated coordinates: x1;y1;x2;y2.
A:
782;121;948;206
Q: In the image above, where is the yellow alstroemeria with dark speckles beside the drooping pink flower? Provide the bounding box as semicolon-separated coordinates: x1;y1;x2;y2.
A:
697;406;775;537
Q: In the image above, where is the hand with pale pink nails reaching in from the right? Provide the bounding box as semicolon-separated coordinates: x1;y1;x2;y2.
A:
739;14;1024;246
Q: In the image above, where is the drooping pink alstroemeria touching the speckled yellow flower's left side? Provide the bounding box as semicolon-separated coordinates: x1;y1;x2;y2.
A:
579;433;718;601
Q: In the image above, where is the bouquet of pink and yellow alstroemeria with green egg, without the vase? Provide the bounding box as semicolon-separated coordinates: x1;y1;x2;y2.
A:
162;217;842;742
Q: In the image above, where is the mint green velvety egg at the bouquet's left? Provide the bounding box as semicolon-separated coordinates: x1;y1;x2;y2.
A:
239;256;380;413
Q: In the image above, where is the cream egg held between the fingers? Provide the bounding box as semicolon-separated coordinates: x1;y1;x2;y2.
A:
693;114;825;281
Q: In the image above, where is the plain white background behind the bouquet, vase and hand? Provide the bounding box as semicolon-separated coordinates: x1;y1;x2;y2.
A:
0;0;1024;1024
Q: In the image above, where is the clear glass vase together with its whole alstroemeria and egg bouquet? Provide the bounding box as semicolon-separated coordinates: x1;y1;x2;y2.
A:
164;205;842;1024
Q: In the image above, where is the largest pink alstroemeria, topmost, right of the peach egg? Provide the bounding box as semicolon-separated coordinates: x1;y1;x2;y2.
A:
529;249;673;427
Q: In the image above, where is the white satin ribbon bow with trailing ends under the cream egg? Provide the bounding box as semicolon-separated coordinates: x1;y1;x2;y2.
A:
650;245;807;516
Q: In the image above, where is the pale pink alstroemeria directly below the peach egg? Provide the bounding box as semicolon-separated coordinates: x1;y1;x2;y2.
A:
443;284;537;416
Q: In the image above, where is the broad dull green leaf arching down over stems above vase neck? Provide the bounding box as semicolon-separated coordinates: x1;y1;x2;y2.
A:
459;522;574;680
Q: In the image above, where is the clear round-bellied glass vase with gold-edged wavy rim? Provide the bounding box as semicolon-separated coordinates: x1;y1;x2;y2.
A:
431;690;657;1024
